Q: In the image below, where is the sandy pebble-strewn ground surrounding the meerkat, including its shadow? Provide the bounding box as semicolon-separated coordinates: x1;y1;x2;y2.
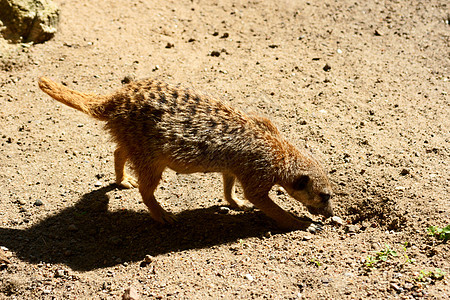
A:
0;0;450;299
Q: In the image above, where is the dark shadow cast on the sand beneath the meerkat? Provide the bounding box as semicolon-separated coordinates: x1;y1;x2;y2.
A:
0;184;277;271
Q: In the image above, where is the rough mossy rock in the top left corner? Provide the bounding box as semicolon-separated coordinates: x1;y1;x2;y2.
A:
0;0;59;43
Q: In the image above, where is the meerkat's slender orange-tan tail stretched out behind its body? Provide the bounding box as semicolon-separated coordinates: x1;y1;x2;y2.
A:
39;77;107;120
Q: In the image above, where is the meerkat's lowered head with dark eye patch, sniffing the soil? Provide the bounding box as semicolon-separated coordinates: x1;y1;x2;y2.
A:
283;172;333;218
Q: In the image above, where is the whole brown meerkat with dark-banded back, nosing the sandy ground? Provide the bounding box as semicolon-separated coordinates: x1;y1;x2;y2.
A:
39;77;333;230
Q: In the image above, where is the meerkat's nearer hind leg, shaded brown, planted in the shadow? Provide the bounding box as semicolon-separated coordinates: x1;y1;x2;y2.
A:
138;166;176;224
